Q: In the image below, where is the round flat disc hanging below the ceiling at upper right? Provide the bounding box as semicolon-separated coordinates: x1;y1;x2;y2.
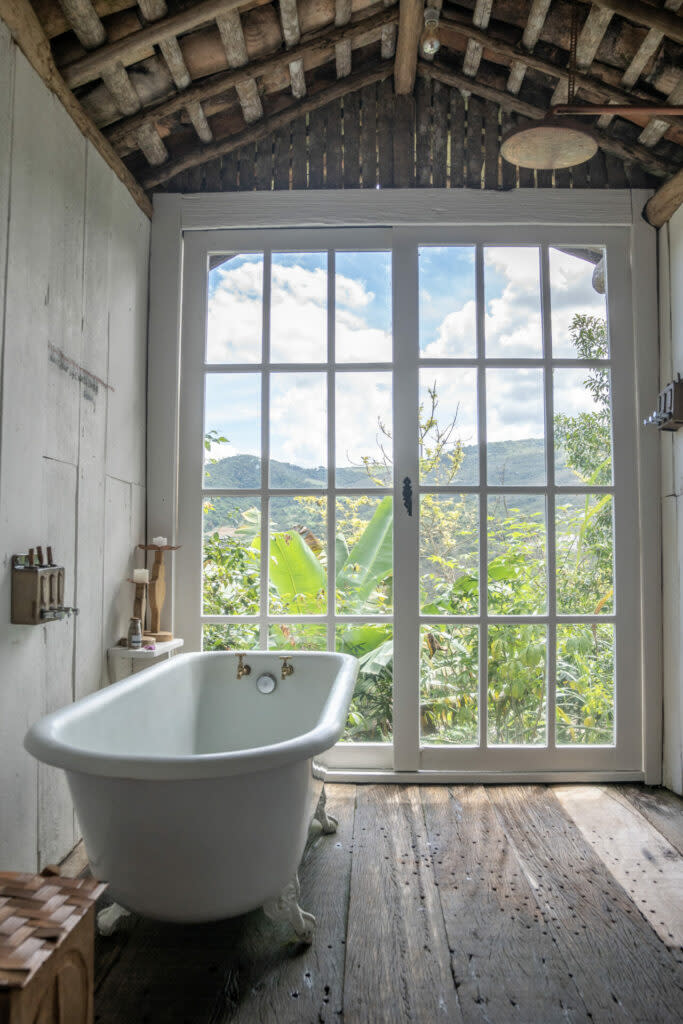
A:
501;120;598;171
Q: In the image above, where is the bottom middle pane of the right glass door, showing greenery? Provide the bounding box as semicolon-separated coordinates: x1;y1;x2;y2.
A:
488;623;547;746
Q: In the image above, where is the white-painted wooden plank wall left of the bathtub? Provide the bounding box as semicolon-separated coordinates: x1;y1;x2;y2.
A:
0;22;150;870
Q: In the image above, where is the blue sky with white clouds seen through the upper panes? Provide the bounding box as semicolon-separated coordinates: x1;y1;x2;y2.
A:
206;246;605;466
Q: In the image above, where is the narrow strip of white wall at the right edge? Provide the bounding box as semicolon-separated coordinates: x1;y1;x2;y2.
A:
659;208;683;794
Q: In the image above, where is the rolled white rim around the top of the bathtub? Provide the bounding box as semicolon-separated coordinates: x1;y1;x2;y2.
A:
24;650;358;781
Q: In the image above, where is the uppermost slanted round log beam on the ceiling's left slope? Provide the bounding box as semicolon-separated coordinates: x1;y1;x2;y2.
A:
60;0;253;89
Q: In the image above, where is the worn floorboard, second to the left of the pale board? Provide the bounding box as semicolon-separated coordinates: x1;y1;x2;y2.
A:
422;785;587;1024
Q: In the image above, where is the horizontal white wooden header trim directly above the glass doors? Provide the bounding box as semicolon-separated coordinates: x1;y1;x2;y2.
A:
172;188;634;231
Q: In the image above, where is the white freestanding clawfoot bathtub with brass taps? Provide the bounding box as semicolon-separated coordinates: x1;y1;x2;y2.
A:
25;651;357;932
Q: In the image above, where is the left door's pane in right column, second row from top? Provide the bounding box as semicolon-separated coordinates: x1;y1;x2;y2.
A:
336;373;393;487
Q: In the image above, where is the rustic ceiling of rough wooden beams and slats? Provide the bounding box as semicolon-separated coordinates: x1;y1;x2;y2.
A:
5;0;683;207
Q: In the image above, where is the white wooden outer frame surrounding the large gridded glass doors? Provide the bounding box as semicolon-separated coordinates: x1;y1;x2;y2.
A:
147;189;661;783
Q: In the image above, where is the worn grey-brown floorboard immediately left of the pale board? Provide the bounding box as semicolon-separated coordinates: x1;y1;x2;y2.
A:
487;785;683;1024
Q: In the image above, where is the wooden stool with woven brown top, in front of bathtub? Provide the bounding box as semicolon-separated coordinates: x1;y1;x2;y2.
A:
0;868;106;1024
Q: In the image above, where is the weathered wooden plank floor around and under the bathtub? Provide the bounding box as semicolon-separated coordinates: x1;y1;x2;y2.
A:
90;785;683;1024
